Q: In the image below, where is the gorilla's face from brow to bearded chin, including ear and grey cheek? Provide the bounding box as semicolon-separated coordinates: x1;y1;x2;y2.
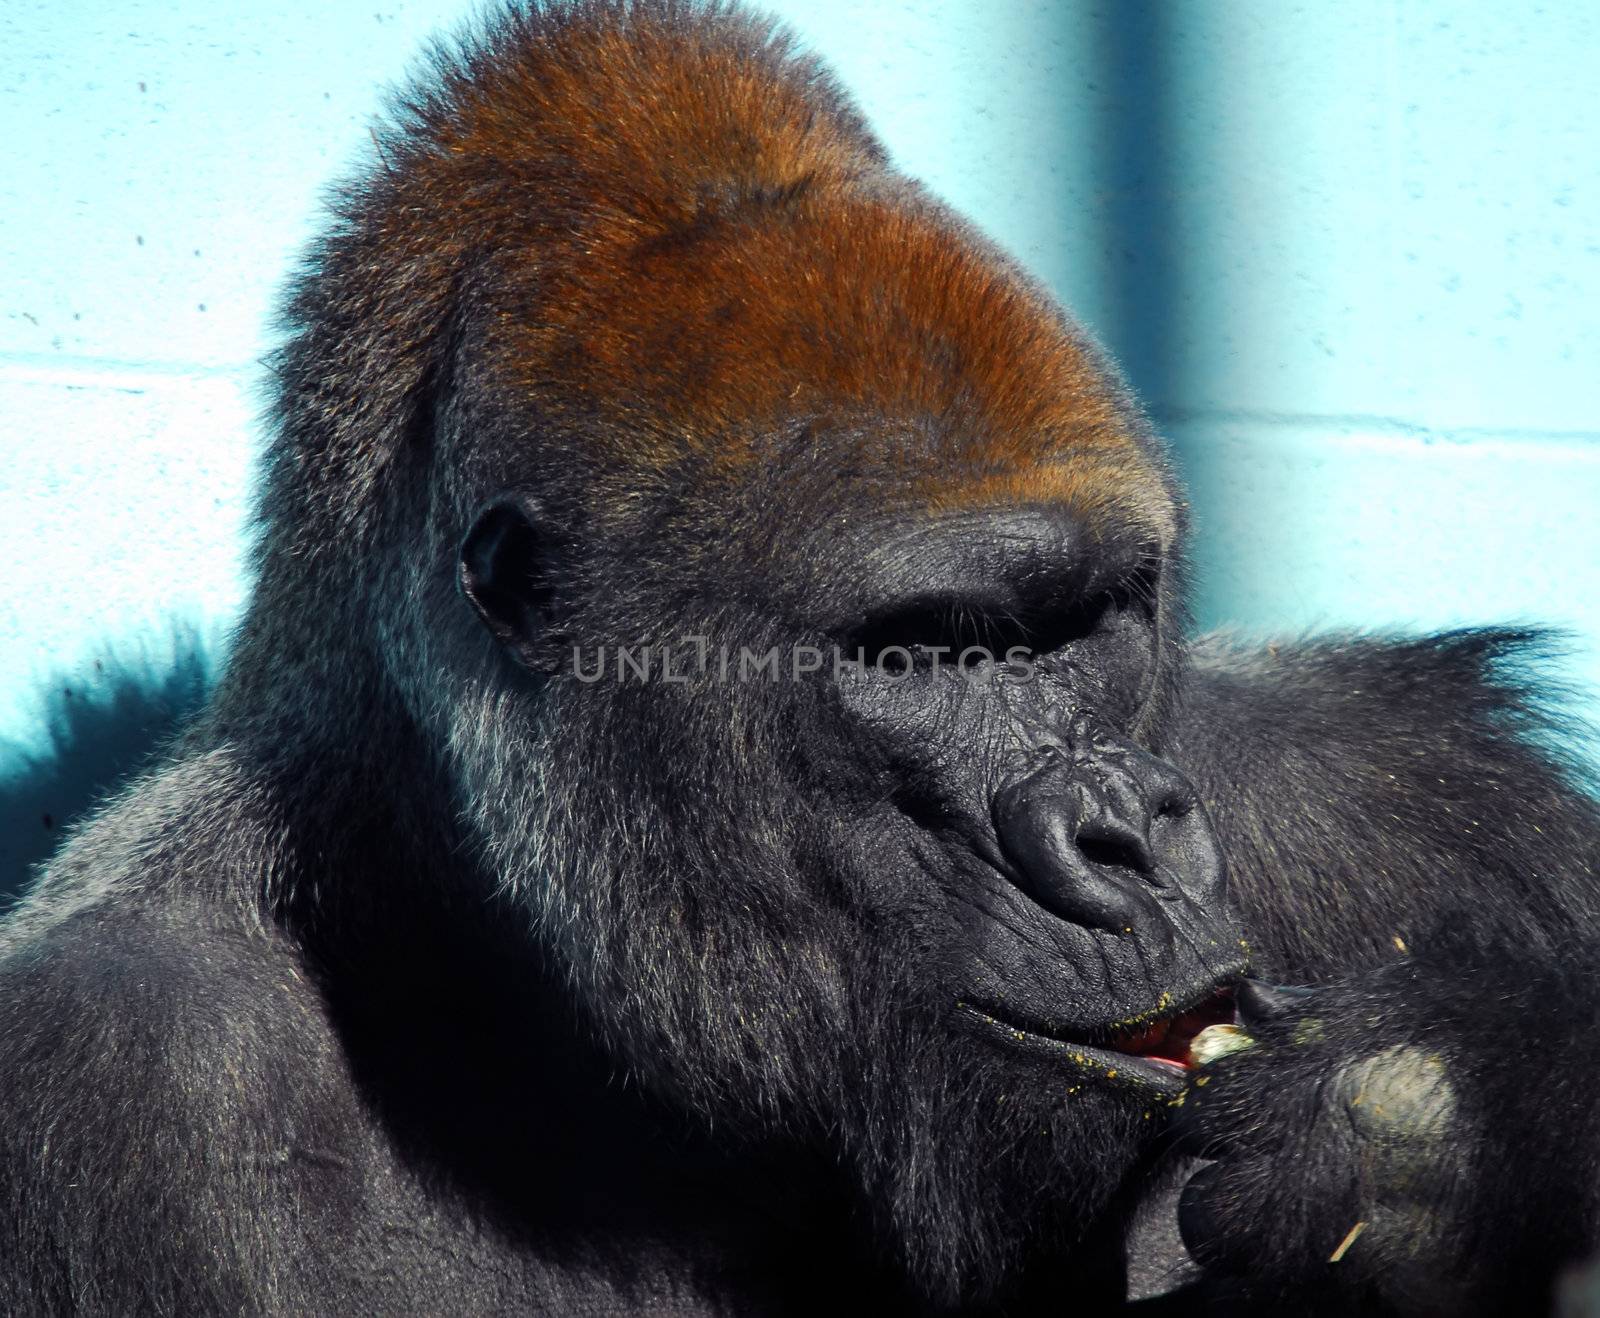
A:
461;460;1242;1294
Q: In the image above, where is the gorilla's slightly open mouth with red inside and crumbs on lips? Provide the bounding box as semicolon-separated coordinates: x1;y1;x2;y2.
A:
962;984;1237;1094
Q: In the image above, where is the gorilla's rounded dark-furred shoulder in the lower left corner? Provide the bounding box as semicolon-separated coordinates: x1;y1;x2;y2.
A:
0;896;378;1313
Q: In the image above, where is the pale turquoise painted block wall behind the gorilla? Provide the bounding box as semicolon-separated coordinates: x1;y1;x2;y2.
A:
0;0;1600;885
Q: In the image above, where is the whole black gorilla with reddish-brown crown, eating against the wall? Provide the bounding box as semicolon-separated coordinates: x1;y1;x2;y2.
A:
0;0;1600;1315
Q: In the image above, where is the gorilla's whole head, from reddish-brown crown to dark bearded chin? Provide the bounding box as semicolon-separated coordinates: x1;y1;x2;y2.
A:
246;3;1243;1297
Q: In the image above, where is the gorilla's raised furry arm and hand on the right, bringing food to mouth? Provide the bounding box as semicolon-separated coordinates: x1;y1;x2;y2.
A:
1174;632;1600;1313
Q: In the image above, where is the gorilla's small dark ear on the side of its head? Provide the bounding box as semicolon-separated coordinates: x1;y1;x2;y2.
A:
456;496;557;670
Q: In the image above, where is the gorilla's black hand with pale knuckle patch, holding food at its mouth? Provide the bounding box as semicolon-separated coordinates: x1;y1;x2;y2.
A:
1174;963;1592;1315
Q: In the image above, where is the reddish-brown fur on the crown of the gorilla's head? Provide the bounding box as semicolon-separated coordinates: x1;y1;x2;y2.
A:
275;3;1174;547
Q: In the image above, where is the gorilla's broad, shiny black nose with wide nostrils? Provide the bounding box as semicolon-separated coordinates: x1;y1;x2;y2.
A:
994;737;1222;933
